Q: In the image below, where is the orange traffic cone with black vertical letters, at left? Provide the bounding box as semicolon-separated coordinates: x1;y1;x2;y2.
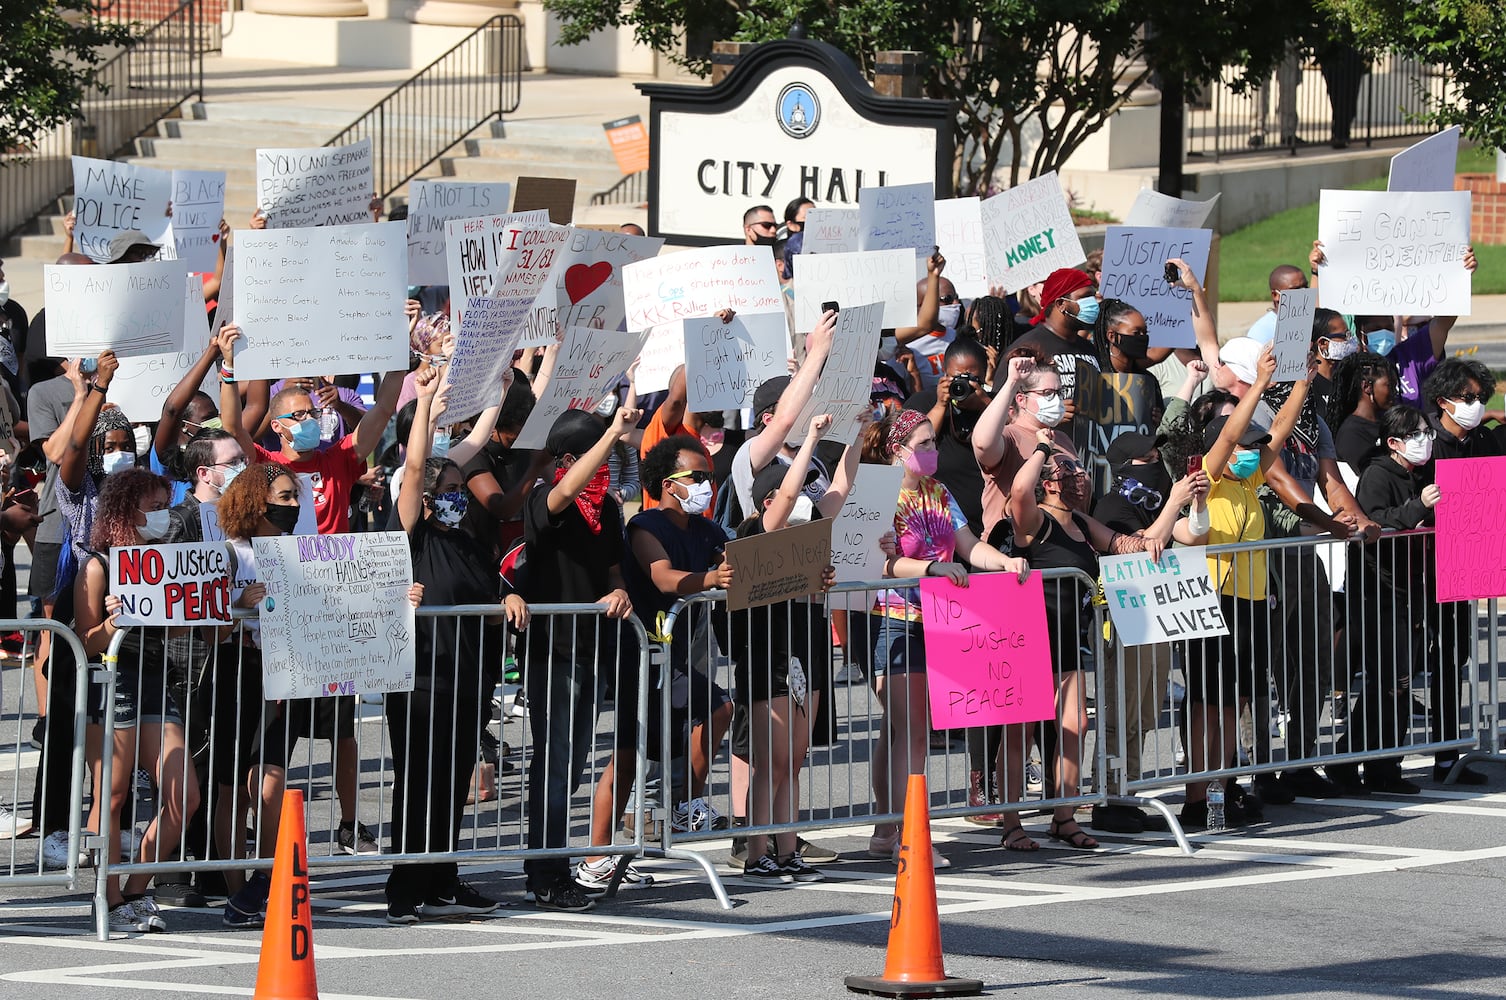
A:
253;788;319;1000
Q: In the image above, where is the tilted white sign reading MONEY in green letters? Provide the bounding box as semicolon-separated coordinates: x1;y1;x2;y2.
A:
979;170;1087;292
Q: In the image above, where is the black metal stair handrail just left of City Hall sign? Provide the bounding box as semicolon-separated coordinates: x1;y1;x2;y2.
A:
325;14;524;197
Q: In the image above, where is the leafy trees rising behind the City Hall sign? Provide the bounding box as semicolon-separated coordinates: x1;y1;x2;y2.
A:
545;0;1306;194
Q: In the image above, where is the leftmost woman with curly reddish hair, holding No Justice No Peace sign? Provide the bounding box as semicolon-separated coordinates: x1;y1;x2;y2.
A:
74;468;199;932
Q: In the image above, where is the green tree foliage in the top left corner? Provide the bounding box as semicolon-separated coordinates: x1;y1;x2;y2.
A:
0;0;130;164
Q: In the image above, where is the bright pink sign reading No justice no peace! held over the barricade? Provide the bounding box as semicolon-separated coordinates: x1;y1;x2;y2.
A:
920;572;1056;729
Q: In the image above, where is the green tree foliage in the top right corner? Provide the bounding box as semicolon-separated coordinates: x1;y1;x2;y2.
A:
1322;0;1506;148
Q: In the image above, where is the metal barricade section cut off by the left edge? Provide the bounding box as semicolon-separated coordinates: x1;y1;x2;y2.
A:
0;619;89;892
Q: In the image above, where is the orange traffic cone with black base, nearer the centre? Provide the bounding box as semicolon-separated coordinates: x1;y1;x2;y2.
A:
845;774;983;997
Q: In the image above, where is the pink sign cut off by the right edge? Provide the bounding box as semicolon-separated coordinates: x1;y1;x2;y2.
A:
1434;458;1506;601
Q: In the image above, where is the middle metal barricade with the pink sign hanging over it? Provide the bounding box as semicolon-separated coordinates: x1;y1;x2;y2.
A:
648;569;1107;908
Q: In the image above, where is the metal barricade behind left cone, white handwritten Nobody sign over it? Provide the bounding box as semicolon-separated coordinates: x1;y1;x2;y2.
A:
91;604;651;940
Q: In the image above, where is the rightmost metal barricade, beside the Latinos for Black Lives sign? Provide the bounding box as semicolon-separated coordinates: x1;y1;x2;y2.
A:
1107;532;1501;851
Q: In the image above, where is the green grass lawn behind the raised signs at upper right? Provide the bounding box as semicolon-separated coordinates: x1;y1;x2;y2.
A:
1218;142;1506;303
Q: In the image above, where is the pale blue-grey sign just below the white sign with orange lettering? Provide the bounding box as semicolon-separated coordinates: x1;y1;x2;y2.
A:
689;312;795;413
